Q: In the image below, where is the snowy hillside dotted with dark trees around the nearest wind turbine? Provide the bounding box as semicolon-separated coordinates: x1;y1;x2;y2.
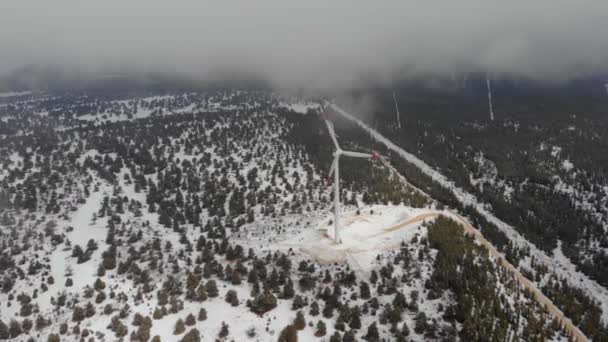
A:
0;91;588;341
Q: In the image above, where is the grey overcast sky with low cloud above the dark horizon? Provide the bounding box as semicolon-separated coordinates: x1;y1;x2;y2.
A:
0;0;608;84
